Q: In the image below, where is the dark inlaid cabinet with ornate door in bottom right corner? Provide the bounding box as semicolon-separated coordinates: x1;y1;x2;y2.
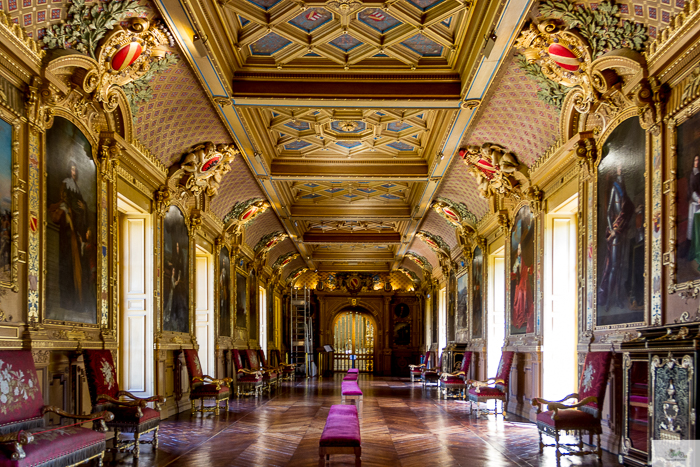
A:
620;323;700;466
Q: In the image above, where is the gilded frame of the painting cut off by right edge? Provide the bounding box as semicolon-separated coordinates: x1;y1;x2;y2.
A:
663;99;700;296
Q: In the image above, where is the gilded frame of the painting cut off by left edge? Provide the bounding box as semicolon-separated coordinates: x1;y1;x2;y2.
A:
0;102;22;292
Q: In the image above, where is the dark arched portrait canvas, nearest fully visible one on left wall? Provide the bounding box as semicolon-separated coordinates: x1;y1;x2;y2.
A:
45;117;98;324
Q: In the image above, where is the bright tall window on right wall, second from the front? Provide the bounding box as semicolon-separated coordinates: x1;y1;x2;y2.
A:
486;247;506;378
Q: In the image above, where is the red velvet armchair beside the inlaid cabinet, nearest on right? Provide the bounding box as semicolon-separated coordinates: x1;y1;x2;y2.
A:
532;352;612;465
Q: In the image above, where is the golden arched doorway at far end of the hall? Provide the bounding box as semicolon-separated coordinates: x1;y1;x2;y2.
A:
333;307;377;373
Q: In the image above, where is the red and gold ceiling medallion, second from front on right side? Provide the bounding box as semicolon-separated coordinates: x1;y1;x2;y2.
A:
460;143;530;204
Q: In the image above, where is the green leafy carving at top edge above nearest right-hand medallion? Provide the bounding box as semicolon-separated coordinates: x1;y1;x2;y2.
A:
540;0;648;59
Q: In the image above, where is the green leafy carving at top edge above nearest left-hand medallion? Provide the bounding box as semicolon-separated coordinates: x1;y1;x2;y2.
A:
43;0;146;58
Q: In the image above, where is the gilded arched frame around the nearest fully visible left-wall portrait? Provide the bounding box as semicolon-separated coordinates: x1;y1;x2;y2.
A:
40;113;102;328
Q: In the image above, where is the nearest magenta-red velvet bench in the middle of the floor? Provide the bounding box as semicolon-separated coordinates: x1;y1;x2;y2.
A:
318;405;362;467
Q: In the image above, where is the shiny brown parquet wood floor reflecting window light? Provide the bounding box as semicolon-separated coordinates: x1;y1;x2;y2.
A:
105;375;618;467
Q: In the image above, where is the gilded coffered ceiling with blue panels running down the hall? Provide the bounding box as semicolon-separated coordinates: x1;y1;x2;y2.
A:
155;0;532;272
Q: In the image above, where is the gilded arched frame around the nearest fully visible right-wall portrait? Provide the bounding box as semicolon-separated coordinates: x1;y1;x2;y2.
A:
587;106;651;331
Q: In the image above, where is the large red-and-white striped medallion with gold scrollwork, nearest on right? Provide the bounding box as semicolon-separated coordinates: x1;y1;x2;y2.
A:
515;20;595;113
